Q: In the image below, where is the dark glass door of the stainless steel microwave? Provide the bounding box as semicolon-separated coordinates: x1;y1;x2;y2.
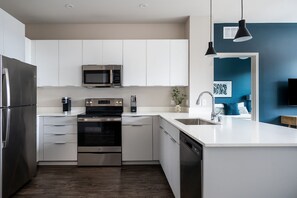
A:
83;69;113;87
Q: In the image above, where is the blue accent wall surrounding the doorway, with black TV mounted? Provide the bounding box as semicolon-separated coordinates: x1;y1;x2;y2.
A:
214;23;297;124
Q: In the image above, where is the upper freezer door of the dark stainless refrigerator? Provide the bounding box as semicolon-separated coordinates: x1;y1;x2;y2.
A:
0;56;36;107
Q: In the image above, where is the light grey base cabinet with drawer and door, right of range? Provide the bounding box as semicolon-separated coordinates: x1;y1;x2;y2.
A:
122;116;153;161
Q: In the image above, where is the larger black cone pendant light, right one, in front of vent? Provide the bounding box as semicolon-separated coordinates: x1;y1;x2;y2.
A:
233;0;253;42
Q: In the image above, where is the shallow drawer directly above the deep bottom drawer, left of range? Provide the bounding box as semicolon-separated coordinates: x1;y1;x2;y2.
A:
43;134;77;144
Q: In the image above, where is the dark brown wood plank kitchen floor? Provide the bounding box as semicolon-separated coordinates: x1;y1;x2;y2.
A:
14;165;174;198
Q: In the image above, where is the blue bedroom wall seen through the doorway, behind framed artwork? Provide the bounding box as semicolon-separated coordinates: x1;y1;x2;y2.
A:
214;58;251;103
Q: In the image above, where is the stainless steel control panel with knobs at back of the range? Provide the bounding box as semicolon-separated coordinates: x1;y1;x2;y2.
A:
85;98;123;107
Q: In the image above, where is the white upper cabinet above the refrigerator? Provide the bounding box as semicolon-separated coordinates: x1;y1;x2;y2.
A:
0;9;25;61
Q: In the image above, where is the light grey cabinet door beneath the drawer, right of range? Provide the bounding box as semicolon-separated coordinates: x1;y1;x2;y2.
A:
122;125;153;161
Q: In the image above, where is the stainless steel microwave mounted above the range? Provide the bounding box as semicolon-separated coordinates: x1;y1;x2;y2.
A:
82;65;122;87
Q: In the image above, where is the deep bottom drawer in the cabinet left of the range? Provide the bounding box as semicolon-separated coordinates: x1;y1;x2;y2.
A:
44;143;77;161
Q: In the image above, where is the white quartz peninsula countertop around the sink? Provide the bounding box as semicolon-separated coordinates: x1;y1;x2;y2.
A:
160;113;297;147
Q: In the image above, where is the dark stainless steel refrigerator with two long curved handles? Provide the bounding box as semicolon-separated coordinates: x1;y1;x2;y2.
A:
0;55;37;198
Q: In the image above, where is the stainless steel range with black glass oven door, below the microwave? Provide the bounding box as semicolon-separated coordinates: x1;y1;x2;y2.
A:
77;98;123;166
